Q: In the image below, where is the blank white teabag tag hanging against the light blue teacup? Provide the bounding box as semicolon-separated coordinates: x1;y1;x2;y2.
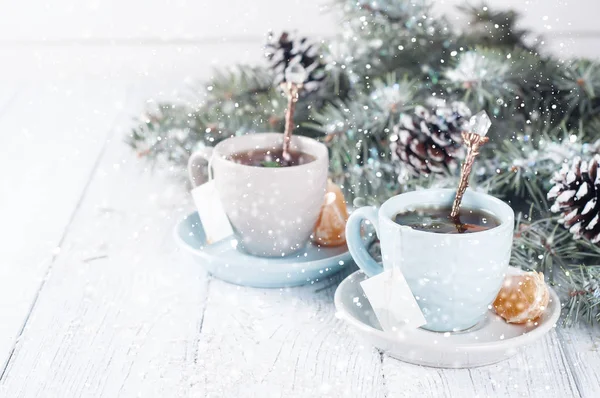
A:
360;269;427;333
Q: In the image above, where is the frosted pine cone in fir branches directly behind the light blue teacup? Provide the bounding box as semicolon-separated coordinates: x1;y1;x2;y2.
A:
390;102;471;175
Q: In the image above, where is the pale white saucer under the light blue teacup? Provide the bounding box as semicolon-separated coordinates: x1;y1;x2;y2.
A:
335;267;560;368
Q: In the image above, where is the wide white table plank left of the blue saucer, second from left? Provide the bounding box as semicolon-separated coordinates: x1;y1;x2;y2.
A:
0;123;207;397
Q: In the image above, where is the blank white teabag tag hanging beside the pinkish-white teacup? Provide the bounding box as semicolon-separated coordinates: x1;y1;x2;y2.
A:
192;180;233;244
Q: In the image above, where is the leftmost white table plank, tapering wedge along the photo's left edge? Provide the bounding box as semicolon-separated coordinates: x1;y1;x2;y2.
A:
0;82;127;373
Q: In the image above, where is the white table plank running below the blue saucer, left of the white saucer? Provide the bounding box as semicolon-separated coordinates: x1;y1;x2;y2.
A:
191;268;385;397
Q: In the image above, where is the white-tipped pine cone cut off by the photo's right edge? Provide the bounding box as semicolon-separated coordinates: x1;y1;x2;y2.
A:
547;155;600;243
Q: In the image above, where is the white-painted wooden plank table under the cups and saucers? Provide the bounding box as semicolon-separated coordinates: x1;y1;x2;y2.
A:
0;78;600;398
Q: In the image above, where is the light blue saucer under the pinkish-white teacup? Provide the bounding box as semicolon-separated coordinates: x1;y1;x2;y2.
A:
175;212;352;288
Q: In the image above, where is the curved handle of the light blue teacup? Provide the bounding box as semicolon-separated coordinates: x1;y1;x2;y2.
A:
346;206;383;277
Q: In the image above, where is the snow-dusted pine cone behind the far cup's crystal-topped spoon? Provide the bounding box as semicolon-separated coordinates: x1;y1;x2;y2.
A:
265;32;325;92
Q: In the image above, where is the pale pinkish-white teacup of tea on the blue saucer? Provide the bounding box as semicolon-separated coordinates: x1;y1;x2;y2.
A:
188;133;329;257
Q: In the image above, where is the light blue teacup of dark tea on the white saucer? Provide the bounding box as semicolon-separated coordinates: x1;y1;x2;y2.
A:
346;189;515;332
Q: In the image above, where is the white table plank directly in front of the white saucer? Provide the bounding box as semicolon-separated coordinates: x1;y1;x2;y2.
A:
383;331;580;398
